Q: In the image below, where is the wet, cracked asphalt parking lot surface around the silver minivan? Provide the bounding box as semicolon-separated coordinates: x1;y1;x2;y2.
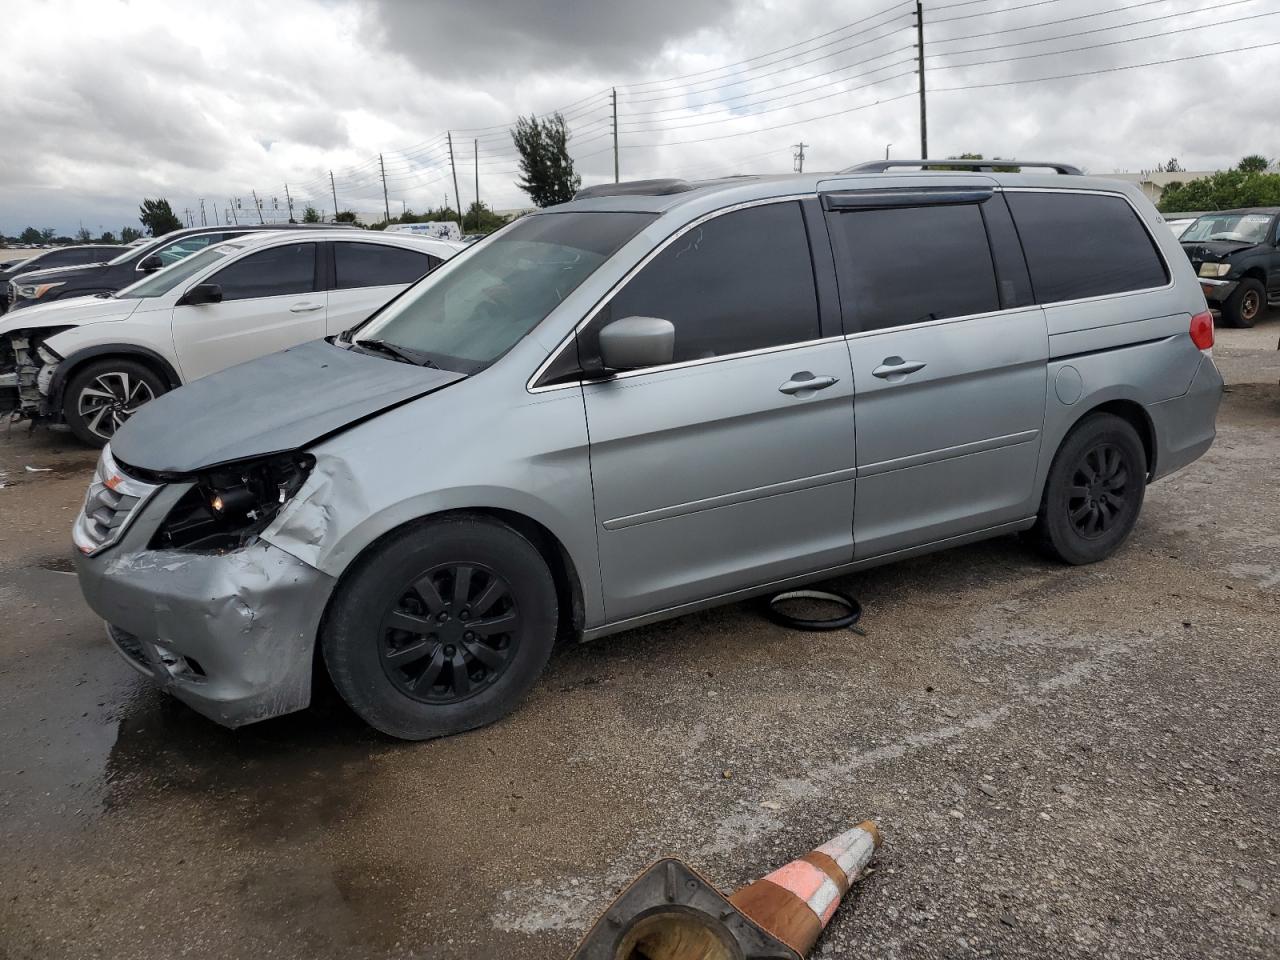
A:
0;316;1280;960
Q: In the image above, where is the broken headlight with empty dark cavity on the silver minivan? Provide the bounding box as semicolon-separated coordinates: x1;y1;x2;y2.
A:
151;453;315;552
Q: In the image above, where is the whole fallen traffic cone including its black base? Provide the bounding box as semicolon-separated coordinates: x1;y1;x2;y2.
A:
570;820;881;960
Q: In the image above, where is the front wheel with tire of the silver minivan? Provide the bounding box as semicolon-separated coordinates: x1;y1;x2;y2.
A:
320;516;558;740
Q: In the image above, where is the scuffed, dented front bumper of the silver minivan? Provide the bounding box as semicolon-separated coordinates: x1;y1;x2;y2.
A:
76;473;334;727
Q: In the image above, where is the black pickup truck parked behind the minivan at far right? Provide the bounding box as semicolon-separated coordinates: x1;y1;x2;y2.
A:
1179;206;1280;326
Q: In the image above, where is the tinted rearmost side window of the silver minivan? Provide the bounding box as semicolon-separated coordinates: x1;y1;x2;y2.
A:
1006;191;1169;303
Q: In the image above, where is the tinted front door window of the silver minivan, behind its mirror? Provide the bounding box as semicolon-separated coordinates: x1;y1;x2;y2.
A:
581;201;820;364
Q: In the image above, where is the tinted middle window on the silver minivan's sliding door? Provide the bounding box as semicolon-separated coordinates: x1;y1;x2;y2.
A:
828;204;1000;330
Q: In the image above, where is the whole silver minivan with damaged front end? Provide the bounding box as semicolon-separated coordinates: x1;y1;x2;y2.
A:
74;160;1222;739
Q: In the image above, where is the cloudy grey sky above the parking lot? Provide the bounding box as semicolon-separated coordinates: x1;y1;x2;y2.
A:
0;0;1280;234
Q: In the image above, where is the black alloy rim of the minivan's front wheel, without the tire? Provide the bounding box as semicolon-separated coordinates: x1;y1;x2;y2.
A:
380;563;520;704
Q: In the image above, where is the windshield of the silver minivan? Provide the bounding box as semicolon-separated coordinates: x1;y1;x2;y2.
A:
356;212;654;374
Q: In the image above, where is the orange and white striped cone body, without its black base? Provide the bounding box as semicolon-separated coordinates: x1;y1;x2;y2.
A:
728;820;881;956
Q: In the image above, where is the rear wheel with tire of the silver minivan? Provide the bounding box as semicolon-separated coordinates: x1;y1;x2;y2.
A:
1032;413;1147;564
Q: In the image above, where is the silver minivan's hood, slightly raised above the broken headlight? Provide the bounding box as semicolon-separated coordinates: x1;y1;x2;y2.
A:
111;340;465;475
